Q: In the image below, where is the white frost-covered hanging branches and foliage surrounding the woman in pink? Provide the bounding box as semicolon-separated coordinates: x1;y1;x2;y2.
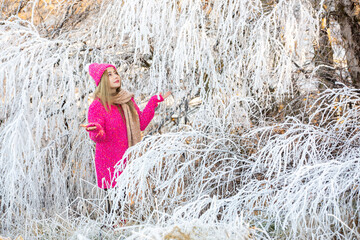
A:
0;0;360;239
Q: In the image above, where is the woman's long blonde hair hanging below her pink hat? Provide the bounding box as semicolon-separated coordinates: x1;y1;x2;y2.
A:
94;70;121;112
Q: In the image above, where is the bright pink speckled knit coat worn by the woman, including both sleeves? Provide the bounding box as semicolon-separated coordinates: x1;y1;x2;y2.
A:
88;95;164;188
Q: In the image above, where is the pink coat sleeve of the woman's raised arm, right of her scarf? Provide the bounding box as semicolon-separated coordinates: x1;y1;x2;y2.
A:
131;94;164;131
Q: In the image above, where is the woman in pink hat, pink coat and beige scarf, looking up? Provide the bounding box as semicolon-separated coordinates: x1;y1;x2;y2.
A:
81;63;170;189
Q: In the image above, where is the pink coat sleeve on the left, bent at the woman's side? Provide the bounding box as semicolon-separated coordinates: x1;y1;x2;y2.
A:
88;101;106;142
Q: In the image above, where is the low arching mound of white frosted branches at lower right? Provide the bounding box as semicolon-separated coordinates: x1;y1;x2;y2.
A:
109;88;360;239
